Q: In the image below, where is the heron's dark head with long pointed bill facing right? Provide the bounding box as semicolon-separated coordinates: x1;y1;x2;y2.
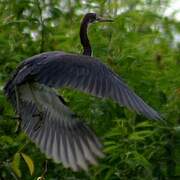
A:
83;13;113;23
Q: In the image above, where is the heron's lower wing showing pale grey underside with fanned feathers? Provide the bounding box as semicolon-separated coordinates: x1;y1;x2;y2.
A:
18;83;103;171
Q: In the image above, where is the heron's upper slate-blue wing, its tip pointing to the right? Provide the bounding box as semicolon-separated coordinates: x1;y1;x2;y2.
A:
14;53;161;120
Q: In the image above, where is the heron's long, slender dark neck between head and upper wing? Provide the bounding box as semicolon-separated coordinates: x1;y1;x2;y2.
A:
80;19;92;56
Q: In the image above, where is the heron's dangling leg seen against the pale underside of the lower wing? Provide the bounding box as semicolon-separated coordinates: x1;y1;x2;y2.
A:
29;84;43;131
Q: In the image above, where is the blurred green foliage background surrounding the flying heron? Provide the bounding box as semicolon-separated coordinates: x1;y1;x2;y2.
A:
0;0;180;180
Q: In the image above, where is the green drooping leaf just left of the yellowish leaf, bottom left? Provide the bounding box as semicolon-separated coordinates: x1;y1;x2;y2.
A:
11;153;22;178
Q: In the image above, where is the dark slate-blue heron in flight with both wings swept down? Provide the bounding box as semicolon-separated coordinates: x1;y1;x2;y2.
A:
4;13;161;171
